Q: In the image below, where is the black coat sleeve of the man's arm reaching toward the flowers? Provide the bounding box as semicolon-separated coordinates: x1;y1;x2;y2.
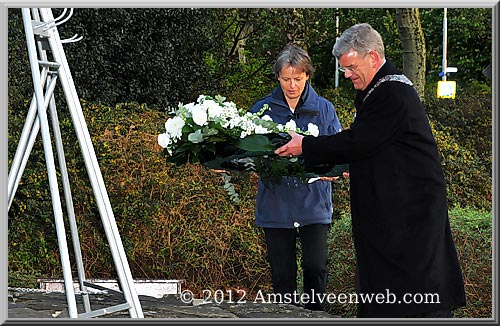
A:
302;82;410;164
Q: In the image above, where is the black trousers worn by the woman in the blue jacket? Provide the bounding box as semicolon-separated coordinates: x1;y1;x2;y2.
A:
264;224;329;310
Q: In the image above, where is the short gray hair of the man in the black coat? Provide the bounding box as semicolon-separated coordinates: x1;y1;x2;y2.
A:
332;23;385;58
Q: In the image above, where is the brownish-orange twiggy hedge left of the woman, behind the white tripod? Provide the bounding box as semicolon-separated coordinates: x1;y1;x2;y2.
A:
9;103;269;296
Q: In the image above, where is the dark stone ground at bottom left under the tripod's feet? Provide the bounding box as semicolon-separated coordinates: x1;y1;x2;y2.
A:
7;292;336;323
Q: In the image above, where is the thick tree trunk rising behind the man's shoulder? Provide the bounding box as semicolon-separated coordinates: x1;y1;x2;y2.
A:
396;8;426;100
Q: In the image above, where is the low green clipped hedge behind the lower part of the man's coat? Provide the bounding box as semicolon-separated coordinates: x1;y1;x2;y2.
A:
325;208;492;318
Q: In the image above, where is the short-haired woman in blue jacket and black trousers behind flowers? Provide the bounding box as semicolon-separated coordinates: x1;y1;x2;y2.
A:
251;45;341;310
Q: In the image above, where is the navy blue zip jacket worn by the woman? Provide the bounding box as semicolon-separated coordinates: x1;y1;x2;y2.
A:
250;83;342;228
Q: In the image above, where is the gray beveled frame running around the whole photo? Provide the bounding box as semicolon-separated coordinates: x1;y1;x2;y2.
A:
0;0;500;324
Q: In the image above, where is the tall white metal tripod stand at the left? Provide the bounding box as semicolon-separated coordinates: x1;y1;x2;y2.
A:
8;8;144;318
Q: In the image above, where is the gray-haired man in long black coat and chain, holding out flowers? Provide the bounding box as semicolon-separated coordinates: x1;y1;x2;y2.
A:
276;24;465;318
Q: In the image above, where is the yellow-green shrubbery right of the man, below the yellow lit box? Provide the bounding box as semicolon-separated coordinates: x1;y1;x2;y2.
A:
425;86;493;210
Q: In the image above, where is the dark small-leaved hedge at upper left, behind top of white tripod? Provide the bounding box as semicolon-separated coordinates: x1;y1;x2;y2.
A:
8;8;220;107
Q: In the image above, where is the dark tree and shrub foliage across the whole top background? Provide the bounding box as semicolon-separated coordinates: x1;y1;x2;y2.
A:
8;8;492;107
